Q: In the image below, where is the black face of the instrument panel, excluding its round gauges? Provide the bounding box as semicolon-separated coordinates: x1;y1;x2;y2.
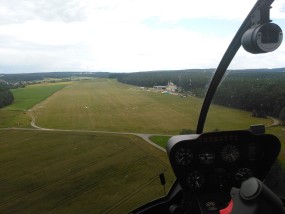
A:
167;130;281;194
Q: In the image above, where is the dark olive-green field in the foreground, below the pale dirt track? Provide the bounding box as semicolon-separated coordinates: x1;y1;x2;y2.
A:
0;130;174;213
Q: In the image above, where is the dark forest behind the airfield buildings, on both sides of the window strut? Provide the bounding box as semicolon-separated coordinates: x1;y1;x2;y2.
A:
110;68;285;122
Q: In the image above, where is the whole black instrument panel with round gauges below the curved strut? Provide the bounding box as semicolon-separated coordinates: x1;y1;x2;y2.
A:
167;131;280;194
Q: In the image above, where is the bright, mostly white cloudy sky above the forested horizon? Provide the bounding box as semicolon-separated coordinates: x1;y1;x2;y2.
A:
0;0;285;73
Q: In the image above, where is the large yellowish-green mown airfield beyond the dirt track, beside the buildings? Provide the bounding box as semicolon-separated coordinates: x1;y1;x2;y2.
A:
30;79;271;134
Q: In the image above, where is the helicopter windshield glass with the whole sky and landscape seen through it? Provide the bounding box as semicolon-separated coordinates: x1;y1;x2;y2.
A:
0;0;285;213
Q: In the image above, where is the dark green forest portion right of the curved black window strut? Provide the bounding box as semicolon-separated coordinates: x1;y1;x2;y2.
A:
214;71;285;117
